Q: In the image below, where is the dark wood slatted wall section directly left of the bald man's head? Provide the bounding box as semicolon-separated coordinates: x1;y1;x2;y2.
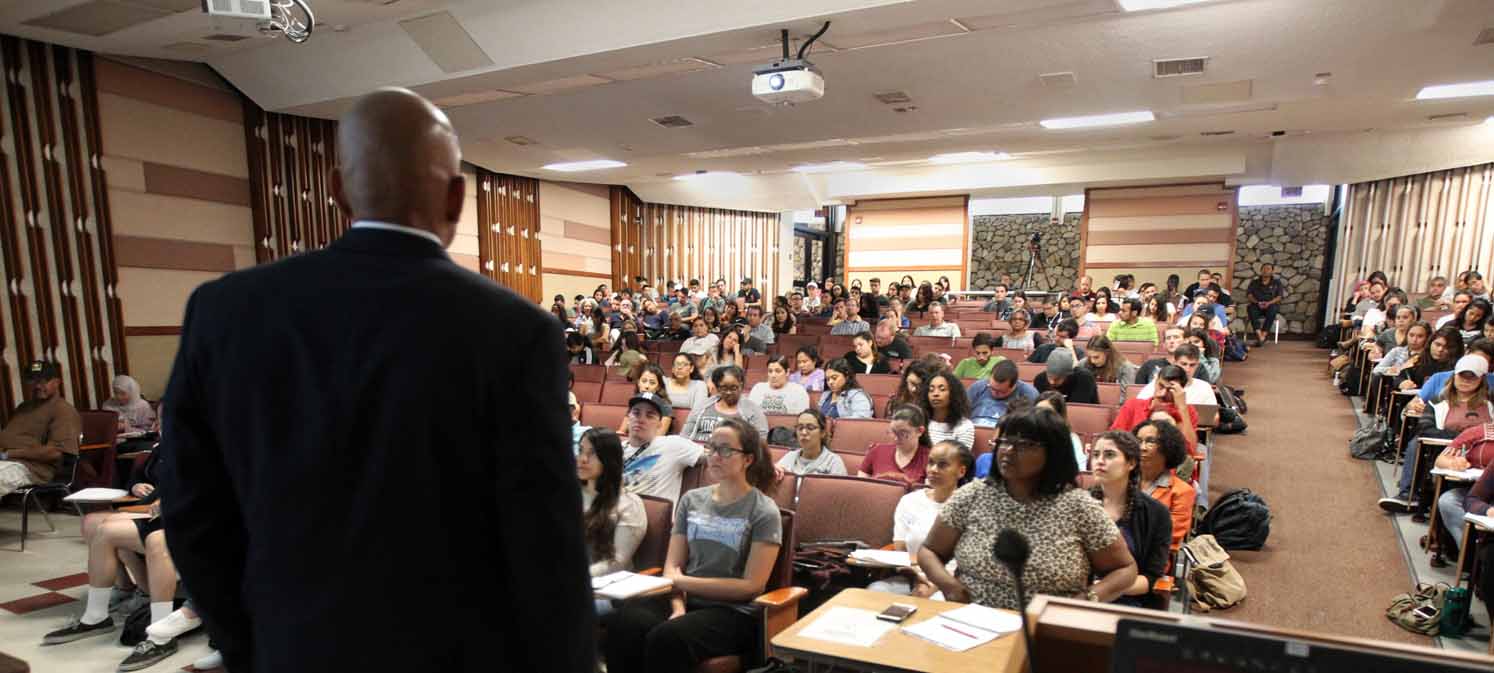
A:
244;99;351;263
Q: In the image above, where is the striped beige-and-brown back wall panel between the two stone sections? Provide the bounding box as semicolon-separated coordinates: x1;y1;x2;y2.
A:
1079;182;1239;287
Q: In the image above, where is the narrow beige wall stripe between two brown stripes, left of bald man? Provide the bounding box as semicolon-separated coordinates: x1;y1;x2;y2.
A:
109;188;254;247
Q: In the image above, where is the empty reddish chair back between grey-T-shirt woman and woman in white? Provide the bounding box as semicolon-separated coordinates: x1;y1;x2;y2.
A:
795;474;907;549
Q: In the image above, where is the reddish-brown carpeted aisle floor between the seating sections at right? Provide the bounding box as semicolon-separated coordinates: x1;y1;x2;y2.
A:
1209;341;1431;645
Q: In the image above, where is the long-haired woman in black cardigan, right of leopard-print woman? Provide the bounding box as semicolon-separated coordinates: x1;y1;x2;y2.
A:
1089;431;1173;607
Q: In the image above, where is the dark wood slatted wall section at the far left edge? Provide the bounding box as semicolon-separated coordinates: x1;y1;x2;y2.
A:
0;36;128;420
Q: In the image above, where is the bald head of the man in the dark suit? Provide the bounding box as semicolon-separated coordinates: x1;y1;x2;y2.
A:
332;88;466;245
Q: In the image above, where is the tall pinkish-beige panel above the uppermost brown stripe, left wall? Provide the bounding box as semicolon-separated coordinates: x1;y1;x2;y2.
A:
99;94;249;178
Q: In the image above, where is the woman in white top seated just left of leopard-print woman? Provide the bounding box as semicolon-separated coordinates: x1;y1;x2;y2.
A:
867;441;976;598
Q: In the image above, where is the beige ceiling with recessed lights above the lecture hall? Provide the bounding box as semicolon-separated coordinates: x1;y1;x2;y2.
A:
0;0;1494;208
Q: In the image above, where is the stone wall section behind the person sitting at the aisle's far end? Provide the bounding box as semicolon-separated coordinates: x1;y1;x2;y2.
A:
1231;203;1333;334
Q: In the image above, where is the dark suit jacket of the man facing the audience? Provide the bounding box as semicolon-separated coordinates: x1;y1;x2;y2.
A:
160;229;595;673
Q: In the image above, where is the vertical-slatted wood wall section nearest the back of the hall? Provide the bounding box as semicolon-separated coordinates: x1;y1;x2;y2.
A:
611;187;783;296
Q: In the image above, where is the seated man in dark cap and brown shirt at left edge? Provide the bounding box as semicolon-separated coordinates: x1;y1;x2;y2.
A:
0;360;82;497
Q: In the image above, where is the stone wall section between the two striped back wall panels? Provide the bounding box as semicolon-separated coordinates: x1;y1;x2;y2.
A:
970;212;1080;290
